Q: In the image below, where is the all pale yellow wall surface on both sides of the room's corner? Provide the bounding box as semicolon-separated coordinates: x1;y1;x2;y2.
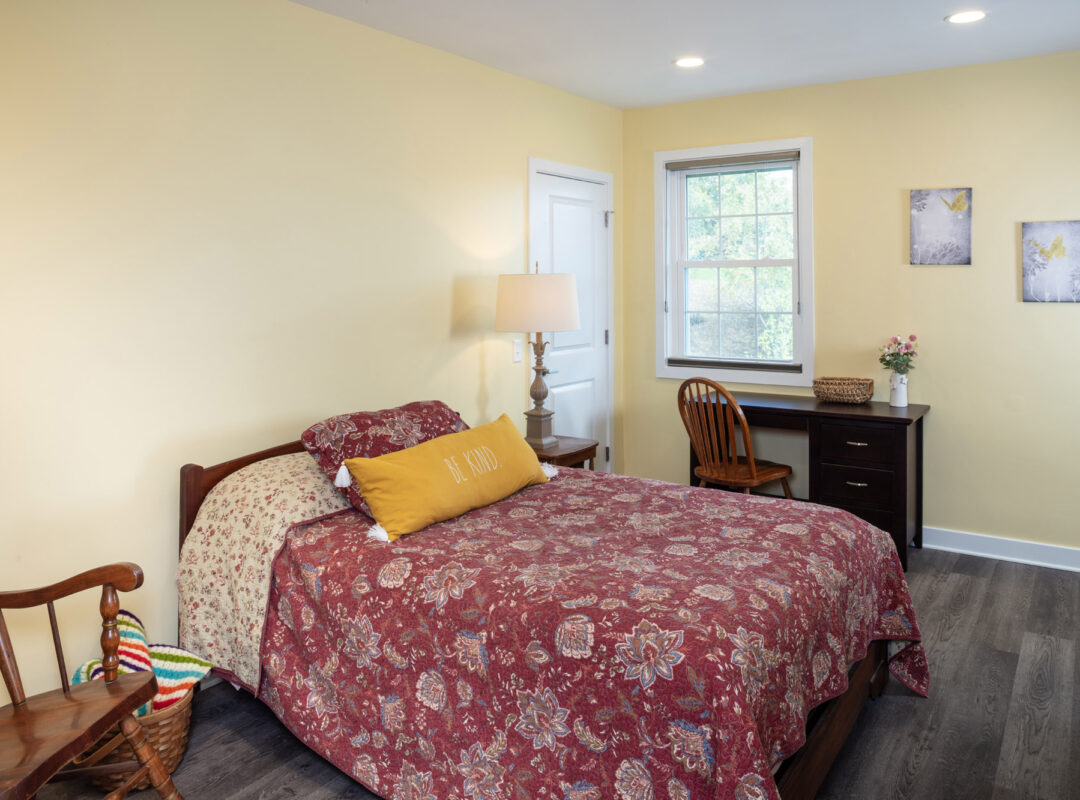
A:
0;0;1080;703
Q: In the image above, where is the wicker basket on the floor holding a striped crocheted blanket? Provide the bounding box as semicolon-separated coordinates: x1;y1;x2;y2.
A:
79;690;194;791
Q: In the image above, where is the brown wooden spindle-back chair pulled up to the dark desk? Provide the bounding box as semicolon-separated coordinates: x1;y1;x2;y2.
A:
678;378;792;499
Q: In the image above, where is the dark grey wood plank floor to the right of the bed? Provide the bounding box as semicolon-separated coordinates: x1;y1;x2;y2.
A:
819;550;1080;800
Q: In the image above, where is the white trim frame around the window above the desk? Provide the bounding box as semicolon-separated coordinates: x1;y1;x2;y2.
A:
653;137;814;387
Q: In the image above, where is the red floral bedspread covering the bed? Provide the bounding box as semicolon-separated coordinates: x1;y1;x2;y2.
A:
260;470;929;800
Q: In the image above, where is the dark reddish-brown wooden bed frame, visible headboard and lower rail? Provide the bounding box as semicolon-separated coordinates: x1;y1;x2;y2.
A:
179;442;889;800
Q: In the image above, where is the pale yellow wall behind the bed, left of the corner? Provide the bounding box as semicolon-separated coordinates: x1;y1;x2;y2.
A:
0;0;621;692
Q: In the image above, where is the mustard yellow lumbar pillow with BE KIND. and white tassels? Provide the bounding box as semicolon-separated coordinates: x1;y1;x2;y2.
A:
345;415;548;542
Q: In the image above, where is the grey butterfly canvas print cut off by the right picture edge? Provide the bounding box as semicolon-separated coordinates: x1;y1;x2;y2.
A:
1021;220;1080;302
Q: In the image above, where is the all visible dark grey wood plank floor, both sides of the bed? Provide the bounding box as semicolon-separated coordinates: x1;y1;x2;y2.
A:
39;550;1080;800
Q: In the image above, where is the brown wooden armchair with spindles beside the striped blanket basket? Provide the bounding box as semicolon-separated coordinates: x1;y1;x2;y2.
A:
0;564;183;800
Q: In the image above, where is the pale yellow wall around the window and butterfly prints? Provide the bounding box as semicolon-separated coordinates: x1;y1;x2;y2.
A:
620;52;1080;546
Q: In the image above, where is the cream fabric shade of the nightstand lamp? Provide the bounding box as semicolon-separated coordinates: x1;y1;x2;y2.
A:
495;273;581;334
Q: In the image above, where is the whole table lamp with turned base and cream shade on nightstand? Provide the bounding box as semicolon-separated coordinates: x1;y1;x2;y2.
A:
495;268;581;449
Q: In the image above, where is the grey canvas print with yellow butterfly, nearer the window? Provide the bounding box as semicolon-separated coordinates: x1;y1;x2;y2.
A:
910;188;972;266
